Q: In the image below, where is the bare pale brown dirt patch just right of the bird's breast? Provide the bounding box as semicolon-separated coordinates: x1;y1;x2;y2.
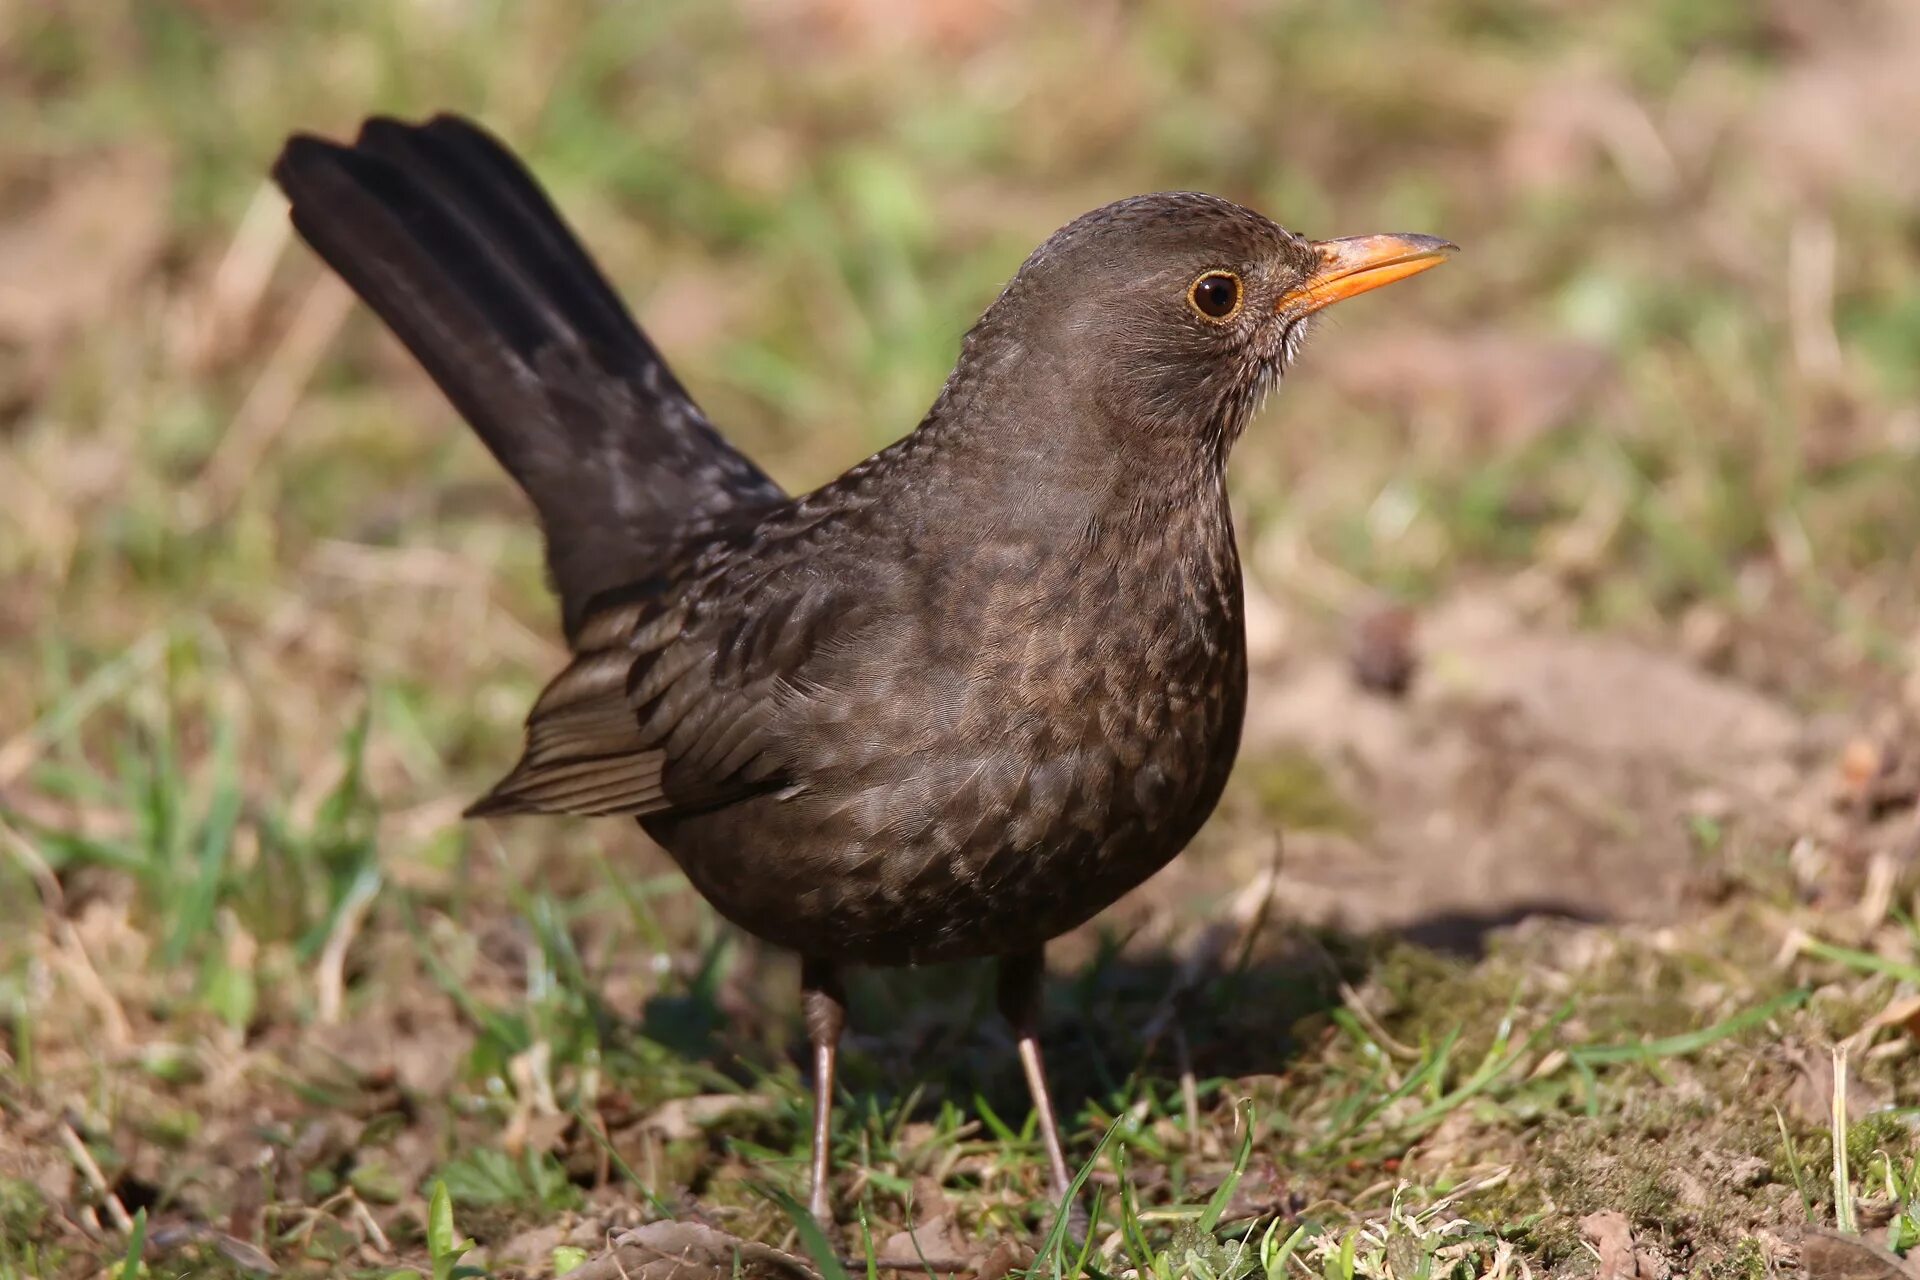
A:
1242;597;1818;931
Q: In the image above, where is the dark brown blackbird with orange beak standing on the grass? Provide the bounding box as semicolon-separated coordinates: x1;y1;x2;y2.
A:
273;115;1455;1222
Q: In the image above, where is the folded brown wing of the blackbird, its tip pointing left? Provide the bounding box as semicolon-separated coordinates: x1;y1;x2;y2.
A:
468;560;862;816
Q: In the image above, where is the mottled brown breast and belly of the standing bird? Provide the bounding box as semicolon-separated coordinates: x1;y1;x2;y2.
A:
664;491;1246;963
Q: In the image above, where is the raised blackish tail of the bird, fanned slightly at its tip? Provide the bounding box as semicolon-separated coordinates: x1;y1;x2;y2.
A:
273;115;781;637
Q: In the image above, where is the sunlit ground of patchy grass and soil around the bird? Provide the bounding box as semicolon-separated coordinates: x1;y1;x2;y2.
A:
0;0;1920;1280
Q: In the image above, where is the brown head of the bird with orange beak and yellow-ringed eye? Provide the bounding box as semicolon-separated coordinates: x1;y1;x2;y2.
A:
962;192;1453;462
